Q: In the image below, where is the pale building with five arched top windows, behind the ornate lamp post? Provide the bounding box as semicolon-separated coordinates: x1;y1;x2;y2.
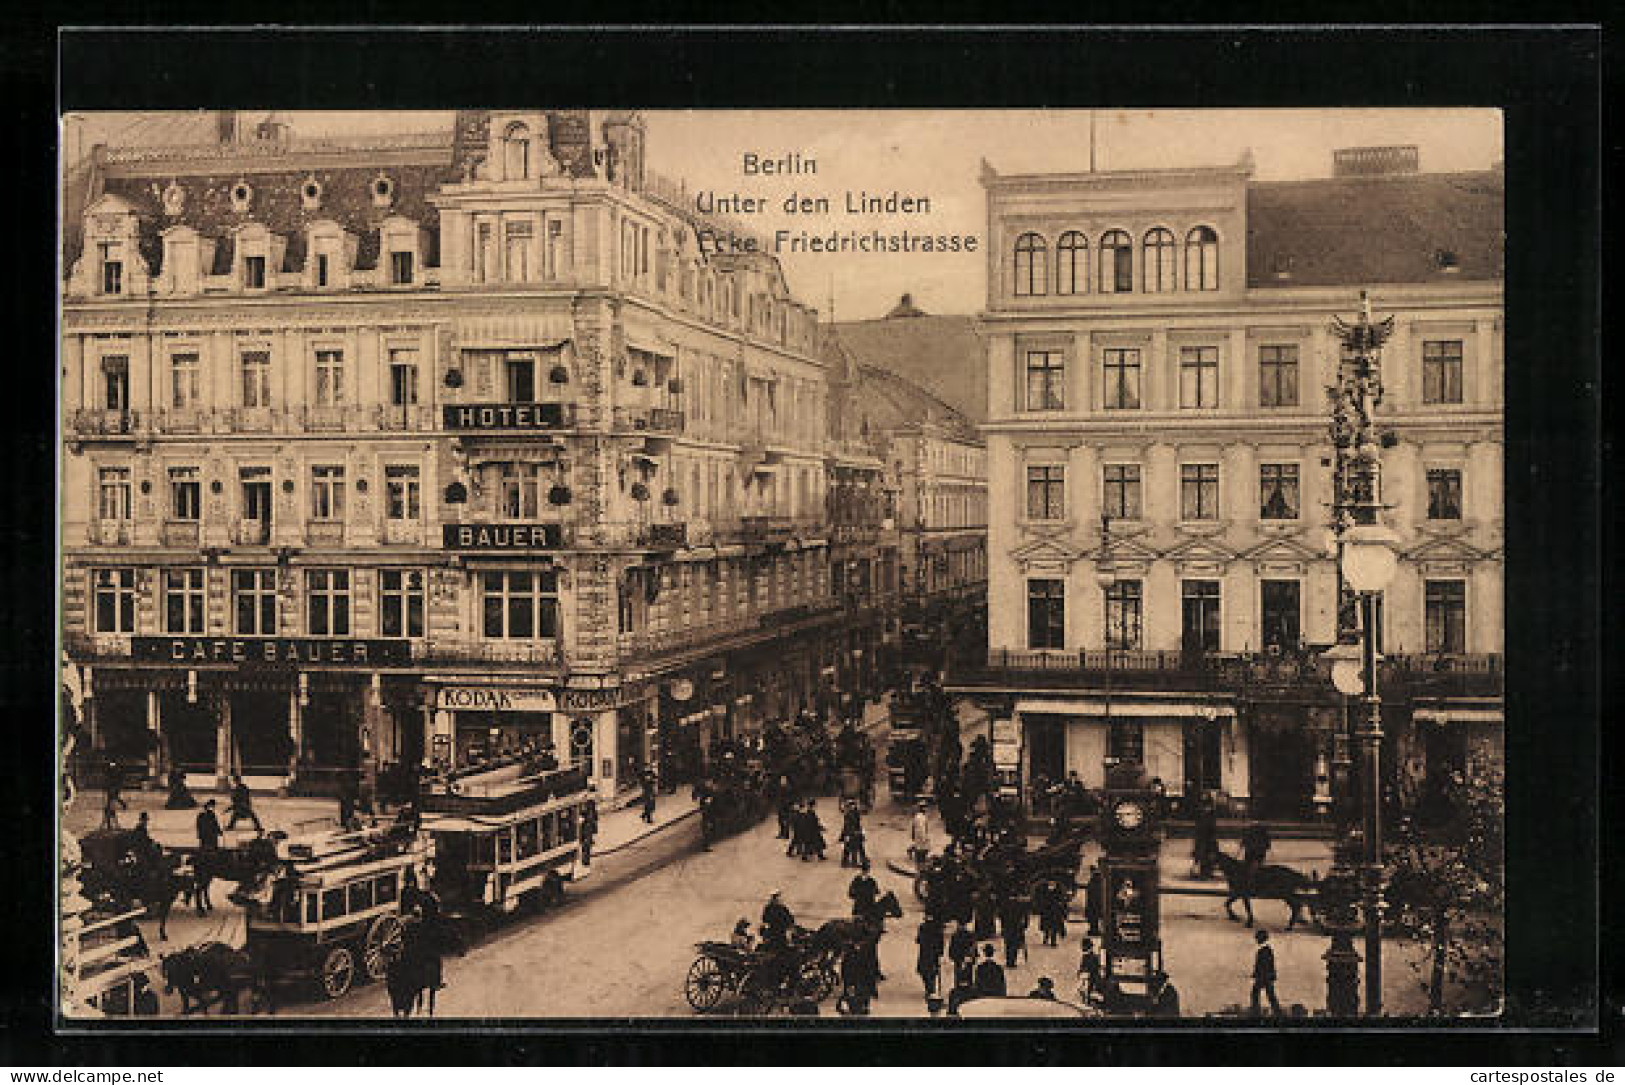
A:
952;148;1505;819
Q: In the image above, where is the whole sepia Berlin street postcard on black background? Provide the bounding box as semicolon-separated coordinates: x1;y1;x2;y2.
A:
57;102;1508;1027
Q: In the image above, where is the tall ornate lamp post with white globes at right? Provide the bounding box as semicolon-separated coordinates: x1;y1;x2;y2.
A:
1324;291;1398;1017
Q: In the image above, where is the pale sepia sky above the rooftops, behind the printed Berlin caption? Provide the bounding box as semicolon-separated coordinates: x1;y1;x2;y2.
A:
76;109;1503;320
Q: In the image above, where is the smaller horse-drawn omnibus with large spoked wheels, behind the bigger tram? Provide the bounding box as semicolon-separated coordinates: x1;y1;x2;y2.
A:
244;827;429;999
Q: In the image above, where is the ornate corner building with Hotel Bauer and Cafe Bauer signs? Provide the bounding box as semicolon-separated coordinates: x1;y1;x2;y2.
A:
62;110;879;793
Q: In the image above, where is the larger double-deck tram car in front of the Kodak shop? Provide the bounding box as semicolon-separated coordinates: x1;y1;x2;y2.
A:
423;763;595;919
